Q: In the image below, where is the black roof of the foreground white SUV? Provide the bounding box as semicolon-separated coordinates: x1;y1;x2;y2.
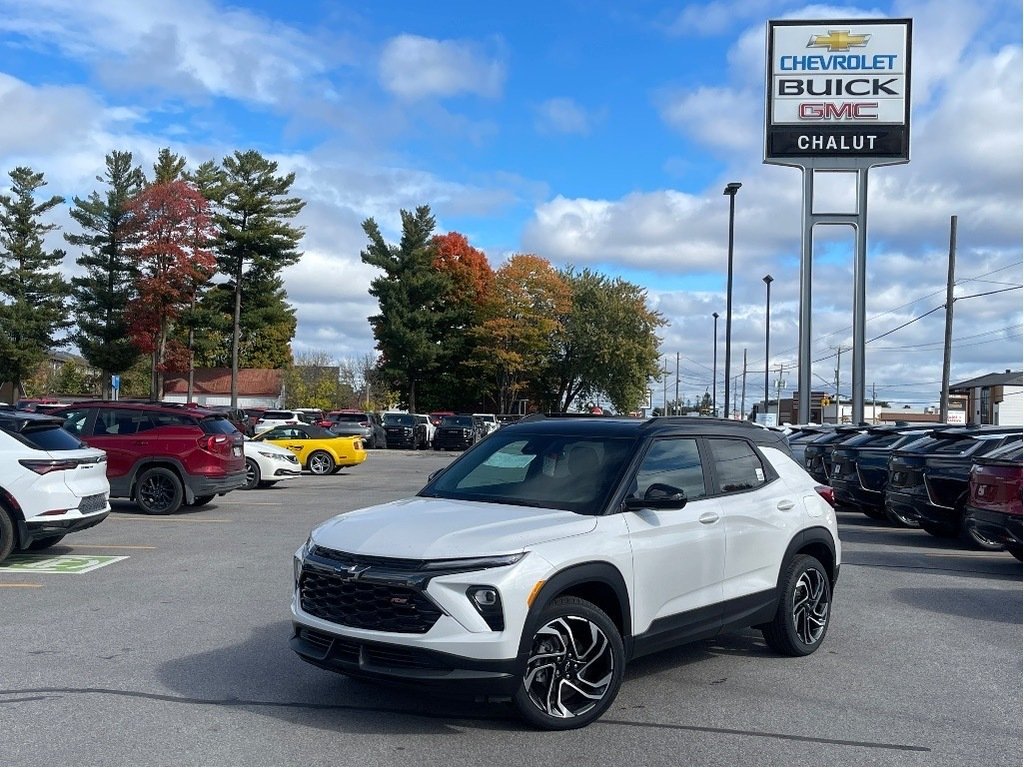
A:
512;414;790;453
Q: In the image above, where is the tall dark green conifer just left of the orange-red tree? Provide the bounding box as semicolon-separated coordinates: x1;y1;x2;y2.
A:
359;206;451;413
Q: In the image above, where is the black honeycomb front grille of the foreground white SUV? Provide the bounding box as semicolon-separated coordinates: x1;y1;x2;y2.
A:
299;565;441;634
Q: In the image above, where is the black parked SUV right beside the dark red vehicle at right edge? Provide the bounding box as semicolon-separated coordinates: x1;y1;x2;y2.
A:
885;426;1021;550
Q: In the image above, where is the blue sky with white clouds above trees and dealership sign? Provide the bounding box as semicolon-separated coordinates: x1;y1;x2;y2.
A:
0;0;1024;409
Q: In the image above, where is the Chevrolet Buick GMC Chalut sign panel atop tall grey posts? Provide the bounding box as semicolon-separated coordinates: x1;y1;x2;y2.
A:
765;18;911;168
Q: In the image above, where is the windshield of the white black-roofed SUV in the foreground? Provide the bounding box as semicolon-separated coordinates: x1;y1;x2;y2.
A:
420;434;635;514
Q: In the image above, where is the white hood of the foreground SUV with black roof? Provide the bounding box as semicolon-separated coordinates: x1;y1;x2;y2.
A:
313;497;597;559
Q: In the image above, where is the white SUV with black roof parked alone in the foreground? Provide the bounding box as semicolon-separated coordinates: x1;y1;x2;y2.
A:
291;416;841;730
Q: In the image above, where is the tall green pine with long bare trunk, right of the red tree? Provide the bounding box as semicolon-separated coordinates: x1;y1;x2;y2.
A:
207;150;305;408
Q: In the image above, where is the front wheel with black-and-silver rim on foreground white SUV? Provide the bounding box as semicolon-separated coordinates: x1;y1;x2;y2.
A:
513;597;626;730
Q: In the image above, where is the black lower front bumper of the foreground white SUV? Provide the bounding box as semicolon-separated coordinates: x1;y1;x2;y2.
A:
290;624;520;698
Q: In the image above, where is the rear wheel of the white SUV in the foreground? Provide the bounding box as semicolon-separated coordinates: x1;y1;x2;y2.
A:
761;555;831;656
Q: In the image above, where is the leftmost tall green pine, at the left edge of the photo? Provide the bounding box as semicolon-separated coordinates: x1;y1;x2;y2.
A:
0;166;71;395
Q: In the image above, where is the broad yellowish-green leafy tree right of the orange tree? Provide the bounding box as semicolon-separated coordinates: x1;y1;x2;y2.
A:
542;268;666;413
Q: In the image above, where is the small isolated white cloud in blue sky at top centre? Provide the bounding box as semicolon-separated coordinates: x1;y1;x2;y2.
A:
380;35;505;100
